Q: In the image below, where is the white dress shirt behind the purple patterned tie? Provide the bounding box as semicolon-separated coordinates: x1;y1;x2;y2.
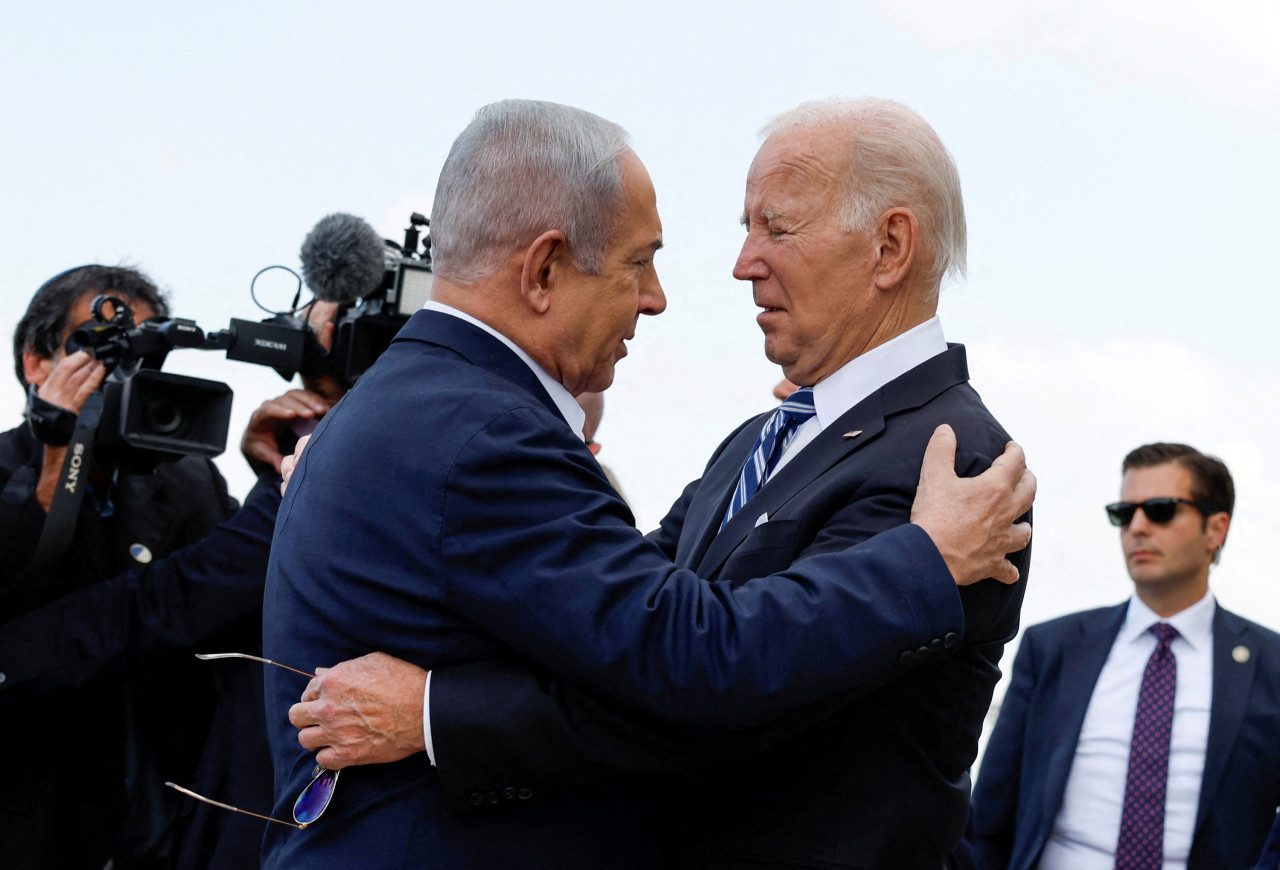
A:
1039;592;1216;870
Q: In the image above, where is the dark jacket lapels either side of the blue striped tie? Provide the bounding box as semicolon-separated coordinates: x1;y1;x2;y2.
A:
686;344;969;577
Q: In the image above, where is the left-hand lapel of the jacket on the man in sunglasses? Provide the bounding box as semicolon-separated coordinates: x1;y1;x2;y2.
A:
1042;601;1129;835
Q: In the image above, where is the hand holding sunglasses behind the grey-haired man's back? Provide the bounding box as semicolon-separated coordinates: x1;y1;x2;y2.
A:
289;653;426;770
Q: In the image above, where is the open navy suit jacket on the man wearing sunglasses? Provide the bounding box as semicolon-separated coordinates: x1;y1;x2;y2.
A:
966;604;1280;870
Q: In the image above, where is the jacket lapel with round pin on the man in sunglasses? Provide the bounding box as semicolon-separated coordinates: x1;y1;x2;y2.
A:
1196;606;1258;830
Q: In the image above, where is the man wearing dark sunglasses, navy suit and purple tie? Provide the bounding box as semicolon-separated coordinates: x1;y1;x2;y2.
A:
966;444;1280;870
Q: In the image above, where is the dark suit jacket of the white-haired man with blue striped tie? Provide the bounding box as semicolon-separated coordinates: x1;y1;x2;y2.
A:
431;345;1029;870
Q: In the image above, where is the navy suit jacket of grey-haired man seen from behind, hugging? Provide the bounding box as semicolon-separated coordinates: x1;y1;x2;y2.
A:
264;312;964;870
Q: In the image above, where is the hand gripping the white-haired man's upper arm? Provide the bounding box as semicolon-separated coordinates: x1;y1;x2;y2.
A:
911;426;1036;586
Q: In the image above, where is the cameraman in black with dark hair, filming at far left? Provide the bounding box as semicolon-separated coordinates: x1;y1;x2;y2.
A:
0;266;333;870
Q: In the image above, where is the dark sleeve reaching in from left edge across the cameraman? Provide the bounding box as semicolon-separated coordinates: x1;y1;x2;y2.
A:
0;487;280;708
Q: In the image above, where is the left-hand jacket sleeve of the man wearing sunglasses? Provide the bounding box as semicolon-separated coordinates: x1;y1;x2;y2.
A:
963;631;1039;870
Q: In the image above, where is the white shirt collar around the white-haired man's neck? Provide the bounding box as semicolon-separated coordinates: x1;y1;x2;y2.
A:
813;316;947;429
